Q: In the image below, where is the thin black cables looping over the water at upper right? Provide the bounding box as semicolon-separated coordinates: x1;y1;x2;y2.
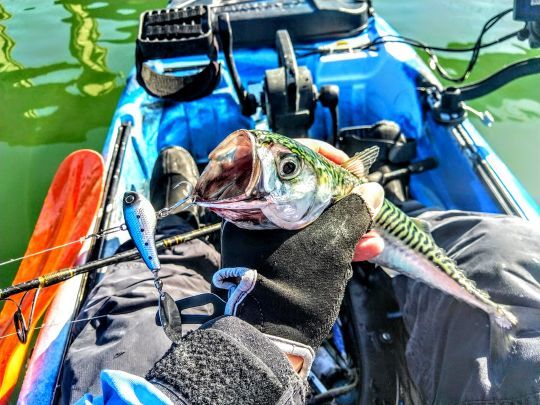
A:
297;8;522;83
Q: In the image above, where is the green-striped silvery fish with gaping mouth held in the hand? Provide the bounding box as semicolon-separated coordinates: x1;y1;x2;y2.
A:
195;130;517;329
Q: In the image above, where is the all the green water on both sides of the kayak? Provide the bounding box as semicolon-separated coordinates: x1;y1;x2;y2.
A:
0;0;540;285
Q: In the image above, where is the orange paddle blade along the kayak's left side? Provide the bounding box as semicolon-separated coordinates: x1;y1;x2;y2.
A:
0;149;105;404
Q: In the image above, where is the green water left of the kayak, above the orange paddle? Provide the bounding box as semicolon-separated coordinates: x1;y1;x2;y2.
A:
0;0;165;285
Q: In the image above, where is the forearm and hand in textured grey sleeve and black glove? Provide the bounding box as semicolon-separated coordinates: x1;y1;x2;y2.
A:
141;185;382;403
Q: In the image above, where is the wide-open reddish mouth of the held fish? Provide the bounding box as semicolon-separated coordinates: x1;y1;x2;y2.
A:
194;129;265;210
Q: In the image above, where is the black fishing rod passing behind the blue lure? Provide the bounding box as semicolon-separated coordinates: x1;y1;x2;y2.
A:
0;224;221;300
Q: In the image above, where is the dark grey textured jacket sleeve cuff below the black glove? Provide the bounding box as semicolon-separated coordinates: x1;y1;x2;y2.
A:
146;316;307;405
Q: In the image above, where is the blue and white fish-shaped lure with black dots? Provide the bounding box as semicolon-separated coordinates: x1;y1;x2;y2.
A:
123;191;161;271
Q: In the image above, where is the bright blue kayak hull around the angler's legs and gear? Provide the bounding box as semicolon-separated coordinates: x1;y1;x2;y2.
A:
17;3;540;403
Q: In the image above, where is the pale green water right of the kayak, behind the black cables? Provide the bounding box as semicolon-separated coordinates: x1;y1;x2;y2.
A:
374;0;540;207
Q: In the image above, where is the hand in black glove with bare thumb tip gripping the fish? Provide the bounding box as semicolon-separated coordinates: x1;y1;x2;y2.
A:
213;183;383;374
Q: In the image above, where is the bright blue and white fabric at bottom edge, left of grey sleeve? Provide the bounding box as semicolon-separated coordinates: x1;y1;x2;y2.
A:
75;370;173;405
